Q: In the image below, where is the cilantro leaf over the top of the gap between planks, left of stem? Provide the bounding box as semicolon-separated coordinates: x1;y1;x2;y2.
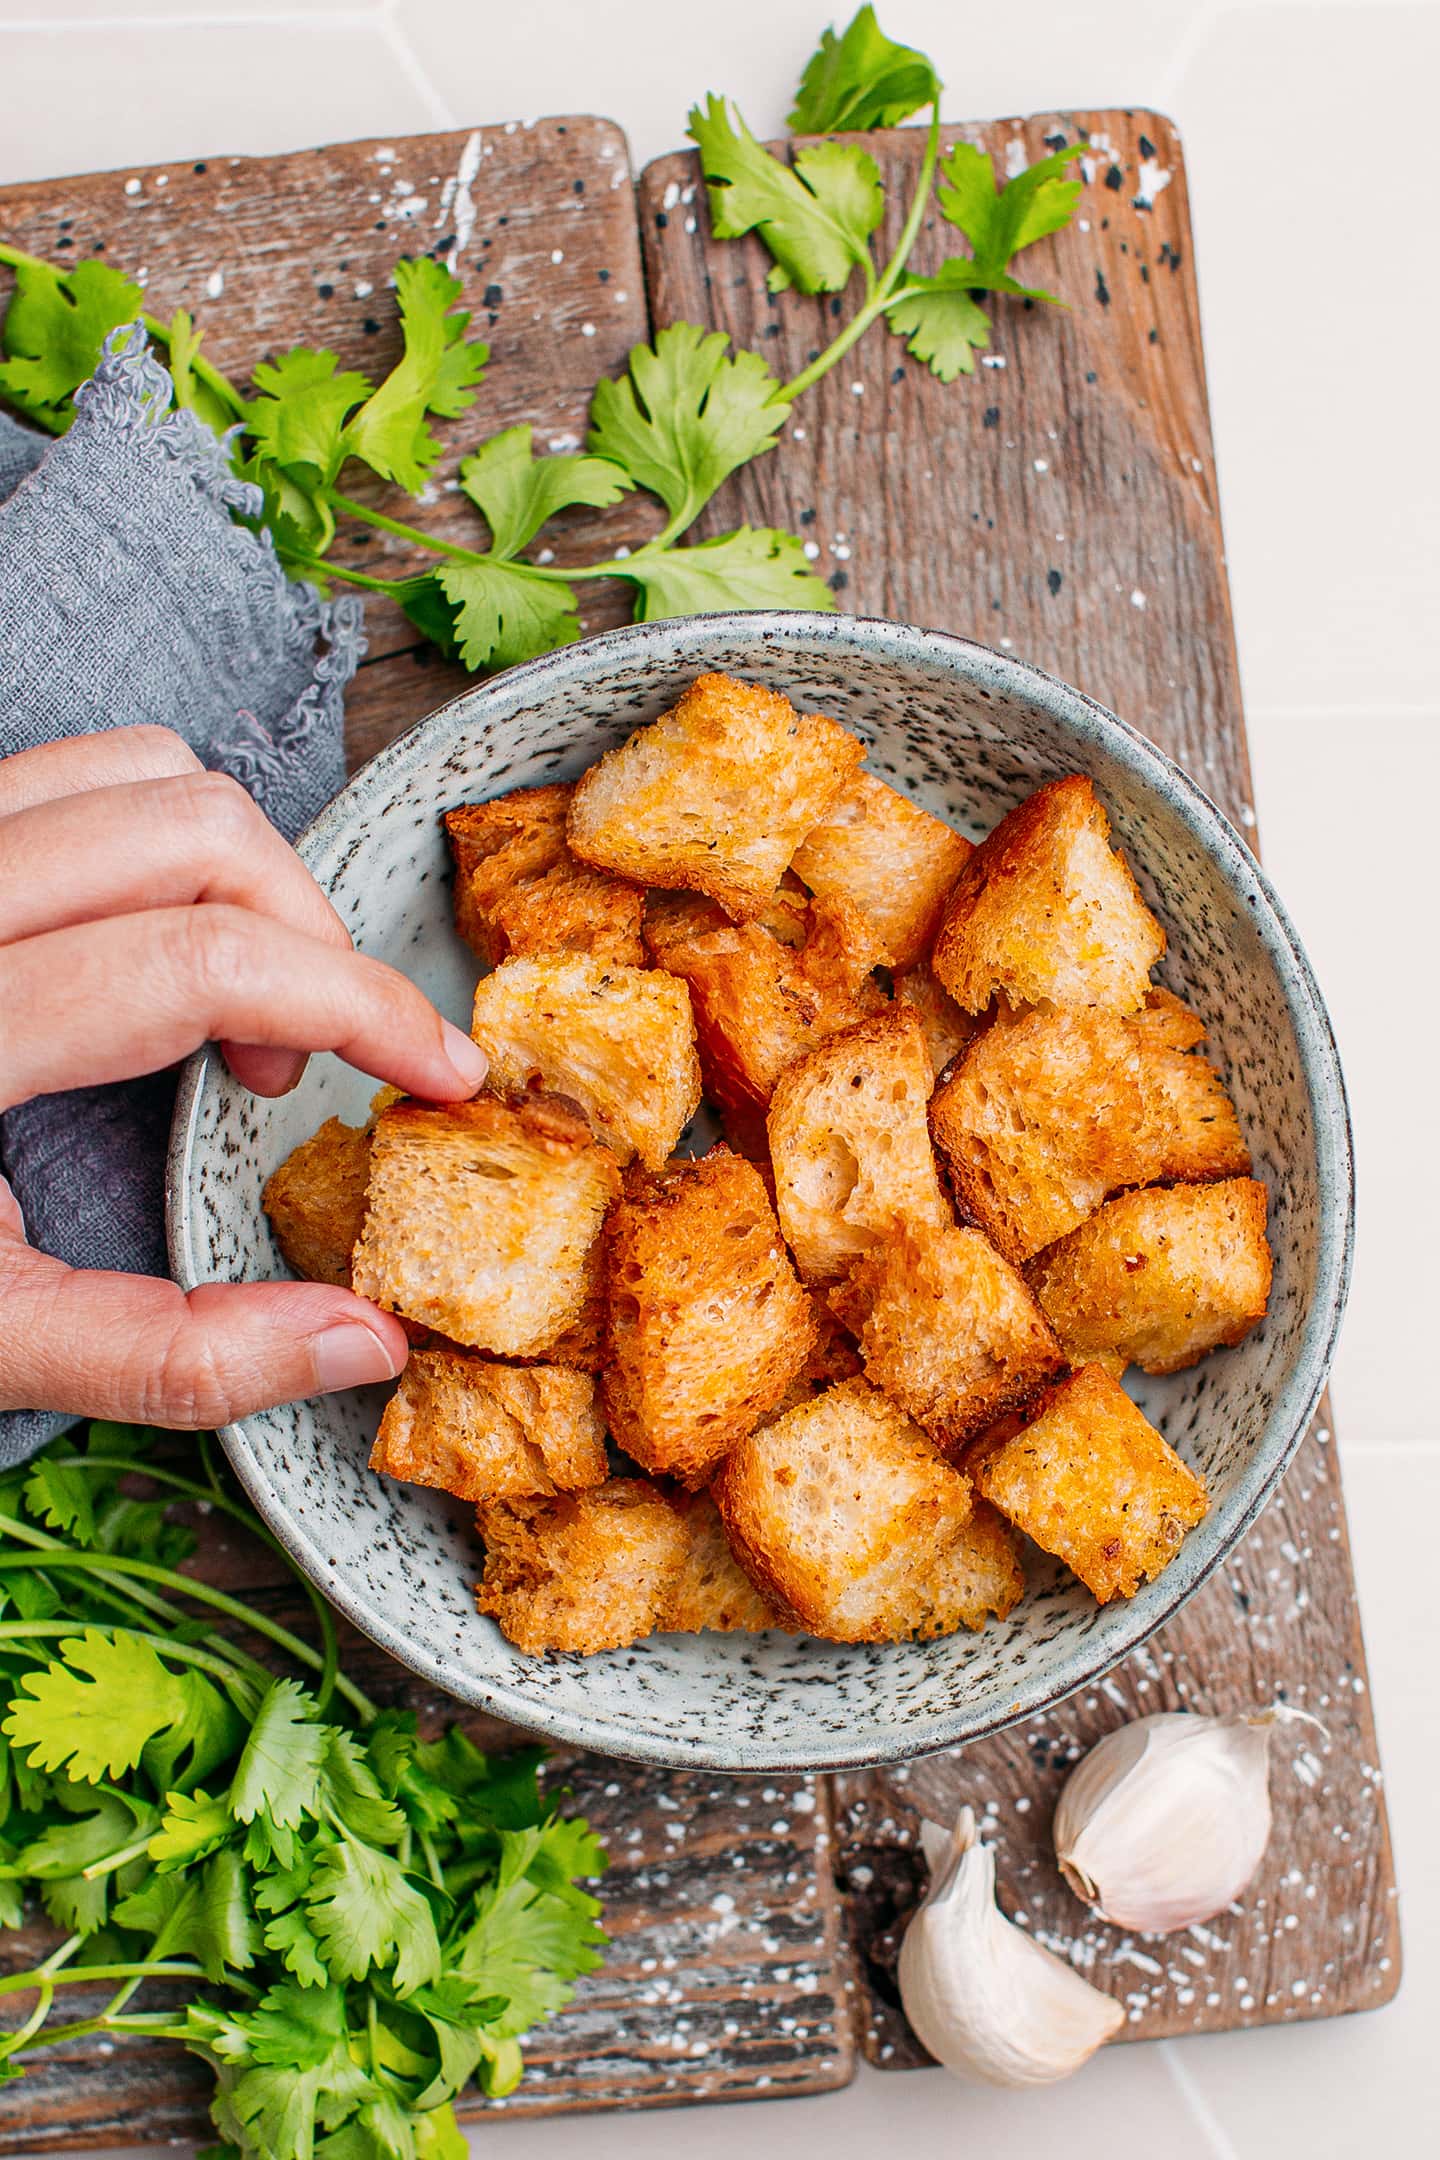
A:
687;93;885;292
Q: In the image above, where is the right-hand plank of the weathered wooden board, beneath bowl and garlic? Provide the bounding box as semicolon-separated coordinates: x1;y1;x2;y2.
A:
639;112;1399;2067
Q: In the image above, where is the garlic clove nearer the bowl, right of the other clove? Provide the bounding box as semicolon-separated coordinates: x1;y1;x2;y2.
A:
1054;1711;1278;1935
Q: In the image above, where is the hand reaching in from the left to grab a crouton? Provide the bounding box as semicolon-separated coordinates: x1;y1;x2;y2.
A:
0;728;486;1428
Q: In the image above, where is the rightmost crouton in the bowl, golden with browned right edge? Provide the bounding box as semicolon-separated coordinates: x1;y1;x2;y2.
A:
1025;1177;1272;1374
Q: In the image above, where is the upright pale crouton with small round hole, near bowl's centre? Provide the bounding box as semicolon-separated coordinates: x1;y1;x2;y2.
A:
769;1007;952;1283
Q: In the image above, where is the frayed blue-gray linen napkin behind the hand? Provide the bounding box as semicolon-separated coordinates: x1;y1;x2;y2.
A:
0;326;365;1467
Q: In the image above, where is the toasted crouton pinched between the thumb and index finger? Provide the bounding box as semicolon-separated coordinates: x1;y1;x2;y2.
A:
352;1095;620;1356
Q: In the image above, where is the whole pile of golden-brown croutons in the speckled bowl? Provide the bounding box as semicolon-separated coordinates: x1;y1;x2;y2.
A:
266;674;1272;1655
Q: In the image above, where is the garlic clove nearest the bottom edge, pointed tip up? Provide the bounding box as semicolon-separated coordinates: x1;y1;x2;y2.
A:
900;1808;1125;2084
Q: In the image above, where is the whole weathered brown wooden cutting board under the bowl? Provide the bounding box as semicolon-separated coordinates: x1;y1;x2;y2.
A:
0;92;1399;2151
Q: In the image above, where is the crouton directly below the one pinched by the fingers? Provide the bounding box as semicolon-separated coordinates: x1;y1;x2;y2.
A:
369;1350;609;1501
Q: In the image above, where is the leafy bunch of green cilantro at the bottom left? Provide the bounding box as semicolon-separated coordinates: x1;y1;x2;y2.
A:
0;1423;604;2160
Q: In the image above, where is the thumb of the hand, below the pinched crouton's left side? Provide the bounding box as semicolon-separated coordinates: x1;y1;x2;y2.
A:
0;1240;408;1430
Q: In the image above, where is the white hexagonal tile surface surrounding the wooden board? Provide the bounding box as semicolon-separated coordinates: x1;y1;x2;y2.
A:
0;0;1440;2160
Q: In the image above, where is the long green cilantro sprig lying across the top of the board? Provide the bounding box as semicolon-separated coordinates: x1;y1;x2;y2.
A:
0;6;1079;672
